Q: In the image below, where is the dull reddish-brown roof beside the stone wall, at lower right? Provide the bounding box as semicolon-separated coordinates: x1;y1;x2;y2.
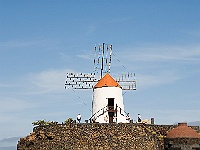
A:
167;123;200;138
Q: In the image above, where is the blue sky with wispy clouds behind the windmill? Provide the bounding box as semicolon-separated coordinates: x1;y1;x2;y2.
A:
0;0;200;146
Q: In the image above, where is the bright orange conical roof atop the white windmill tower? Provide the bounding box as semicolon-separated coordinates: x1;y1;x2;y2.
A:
94;73;121;88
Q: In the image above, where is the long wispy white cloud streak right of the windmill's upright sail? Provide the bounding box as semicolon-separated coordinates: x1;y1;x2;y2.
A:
117;45;200;62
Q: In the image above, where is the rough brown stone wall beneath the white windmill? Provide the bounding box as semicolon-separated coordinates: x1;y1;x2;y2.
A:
17;123;198;150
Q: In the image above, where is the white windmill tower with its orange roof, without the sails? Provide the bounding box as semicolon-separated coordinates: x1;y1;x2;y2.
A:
91;73;129;123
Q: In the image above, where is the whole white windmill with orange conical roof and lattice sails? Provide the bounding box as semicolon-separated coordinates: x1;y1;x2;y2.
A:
65;43;136;123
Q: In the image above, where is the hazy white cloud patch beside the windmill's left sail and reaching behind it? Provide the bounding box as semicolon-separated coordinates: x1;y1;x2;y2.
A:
20;69;94;95
